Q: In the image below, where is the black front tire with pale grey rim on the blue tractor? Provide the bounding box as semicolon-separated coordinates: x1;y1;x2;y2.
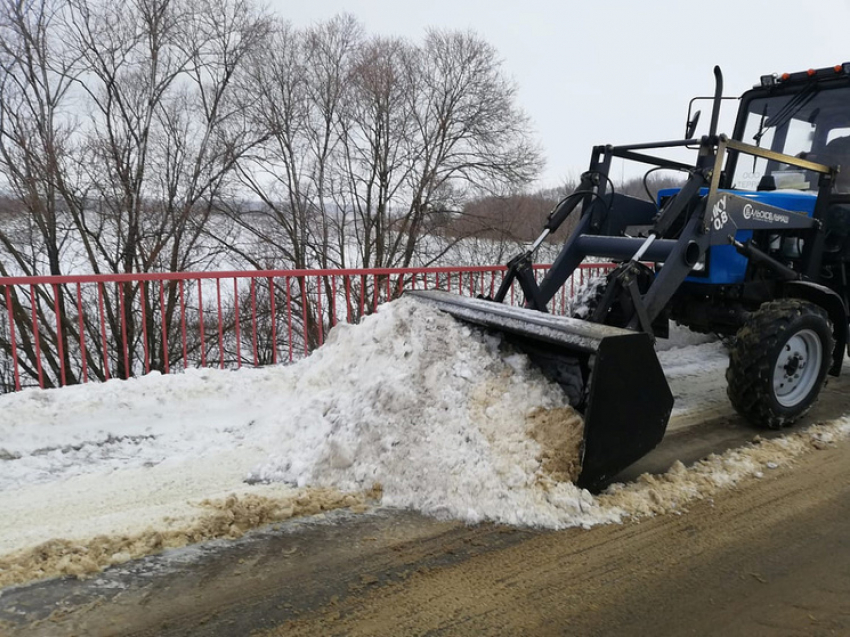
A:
726;299;835;429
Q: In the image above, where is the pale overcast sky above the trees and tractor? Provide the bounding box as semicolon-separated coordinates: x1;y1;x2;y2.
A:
270;0;850;186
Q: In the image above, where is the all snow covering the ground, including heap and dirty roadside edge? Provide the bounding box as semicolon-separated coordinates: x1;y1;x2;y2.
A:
0;299;850;587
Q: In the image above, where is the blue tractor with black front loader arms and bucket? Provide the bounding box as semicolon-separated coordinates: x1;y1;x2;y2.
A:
416;63;850;488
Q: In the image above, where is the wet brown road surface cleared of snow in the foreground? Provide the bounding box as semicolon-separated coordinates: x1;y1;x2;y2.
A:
0;360;850;637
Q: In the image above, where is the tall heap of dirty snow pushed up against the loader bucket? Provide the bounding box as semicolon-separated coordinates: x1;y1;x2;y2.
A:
245;299;612;528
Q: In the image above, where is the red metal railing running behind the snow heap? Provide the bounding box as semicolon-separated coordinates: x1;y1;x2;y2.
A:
0;264;613;391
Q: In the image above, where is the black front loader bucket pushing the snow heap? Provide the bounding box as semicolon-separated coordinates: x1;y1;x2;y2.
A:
406;290;673;489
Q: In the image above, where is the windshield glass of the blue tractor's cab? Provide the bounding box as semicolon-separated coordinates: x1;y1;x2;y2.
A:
732;84;850;192
